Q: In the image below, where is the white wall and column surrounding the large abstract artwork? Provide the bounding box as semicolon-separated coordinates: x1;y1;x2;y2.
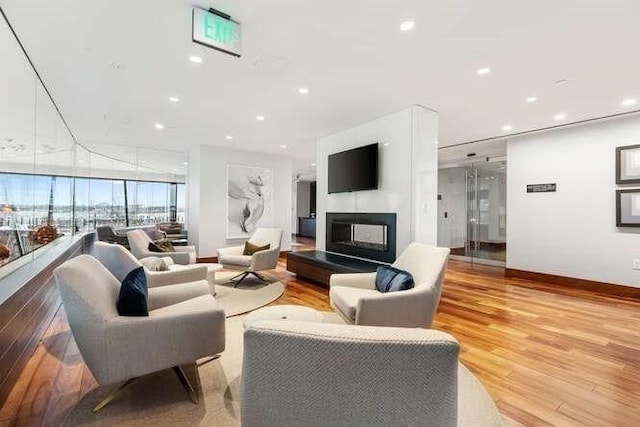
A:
188;145;293;257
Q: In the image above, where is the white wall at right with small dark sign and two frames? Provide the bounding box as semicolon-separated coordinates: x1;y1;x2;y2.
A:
507;116;640;287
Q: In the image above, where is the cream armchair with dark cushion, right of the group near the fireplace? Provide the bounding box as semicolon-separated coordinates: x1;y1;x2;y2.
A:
329;243;449;328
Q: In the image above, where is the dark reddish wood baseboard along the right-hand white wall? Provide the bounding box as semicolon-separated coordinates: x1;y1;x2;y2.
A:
504;268;640;300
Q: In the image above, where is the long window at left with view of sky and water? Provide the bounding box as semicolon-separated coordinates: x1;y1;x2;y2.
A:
0;173;186;266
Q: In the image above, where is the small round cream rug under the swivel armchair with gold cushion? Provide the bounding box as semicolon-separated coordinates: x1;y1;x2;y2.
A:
215;272;284;317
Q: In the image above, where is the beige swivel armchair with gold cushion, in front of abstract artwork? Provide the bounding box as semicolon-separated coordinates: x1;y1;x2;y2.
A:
218;228;282;286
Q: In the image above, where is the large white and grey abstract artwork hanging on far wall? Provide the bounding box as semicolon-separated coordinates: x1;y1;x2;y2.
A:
227;165;273;239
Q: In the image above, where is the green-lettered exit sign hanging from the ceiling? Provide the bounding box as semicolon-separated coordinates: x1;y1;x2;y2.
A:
192;8;242;57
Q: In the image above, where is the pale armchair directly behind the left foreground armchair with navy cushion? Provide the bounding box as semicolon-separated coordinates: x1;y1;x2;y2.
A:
93;242;213;294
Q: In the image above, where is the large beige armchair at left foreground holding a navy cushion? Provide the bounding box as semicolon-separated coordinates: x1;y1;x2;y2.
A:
54;255;225;412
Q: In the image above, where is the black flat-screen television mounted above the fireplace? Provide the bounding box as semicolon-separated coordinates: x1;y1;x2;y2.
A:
328;143;378;194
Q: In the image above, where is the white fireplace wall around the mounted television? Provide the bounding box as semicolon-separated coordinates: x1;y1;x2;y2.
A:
316;106;438;254
